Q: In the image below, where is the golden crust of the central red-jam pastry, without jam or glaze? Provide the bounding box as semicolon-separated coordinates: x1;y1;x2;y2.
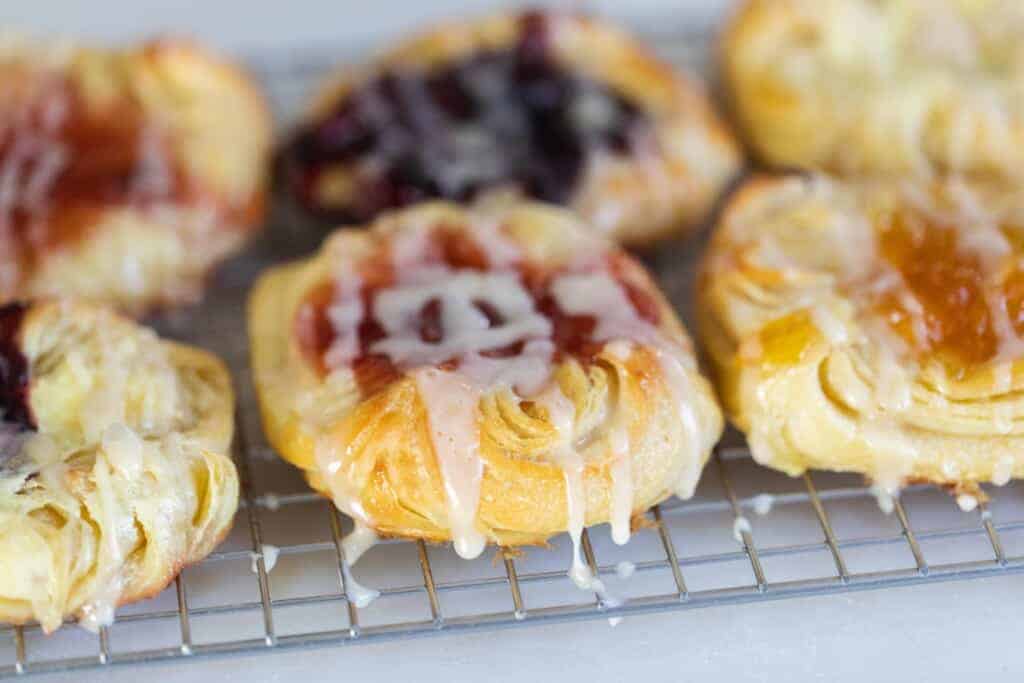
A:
249;198;722;546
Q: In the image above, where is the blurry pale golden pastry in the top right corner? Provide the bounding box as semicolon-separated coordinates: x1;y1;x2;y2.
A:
722;0;1024;179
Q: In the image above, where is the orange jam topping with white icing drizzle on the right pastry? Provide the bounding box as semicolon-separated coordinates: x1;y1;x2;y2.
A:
720;176;1024;493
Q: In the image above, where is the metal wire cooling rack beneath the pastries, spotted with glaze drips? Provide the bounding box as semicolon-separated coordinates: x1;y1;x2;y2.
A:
0;21;1024;676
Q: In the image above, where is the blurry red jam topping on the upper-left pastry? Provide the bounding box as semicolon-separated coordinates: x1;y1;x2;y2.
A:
0;73;186;264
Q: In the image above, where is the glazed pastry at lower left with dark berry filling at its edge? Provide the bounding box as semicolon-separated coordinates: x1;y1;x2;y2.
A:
0;301;239;632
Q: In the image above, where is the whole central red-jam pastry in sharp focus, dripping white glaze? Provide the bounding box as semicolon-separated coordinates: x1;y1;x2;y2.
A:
249;198;722;584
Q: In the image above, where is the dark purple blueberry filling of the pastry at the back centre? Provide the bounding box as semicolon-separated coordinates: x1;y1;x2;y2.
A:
286;12;648;221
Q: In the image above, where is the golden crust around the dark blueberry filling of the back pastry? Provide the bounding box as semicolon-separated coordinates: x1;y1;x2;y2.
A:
292;13;741;246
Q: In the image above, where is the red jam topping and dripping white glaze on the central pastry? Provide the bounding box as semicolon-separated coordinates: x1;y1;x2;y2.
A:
296;218;699;581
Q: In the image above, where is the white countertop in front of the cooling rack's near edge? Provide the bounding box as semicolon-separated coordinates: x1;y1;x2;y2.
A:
19;575;1024;683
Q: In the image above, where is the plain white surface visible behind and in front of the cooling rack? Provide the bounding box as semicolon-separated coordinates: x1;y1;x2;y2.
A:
0;0;1024;683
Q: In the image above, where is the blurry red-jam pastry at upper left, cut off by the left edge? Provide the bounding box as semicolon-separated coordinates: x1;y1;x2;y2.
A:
0;35;270;313
